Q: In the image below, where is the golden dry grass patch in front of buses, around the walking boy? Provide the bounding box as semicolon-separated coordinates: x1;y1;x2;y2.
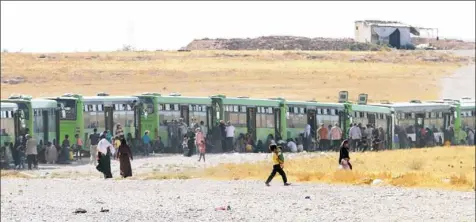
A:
180;147;475;190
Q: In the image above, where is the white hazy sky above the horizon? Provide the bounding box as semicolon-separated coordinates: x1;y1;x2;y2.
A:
1;1;475;52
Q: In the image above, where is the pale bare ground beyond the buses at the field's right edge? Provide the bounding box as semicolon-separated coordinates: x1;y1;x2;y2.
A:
441;50;476;99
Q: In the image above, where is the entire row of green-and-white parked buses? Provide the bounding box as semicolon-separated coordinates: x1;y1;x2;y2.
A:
1;91;475;153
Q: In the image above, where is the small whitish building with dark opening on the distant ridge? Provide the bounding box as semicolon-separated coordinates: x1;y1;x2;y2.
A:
355;20;420;49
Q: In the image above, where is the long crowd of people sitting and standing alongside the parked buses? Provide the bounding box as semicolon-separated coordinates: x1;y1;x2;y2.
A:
1;119;475;176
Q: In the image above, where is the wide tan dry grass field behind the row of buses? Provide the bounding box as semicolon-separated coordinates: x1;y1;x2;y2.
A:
1;51;472;101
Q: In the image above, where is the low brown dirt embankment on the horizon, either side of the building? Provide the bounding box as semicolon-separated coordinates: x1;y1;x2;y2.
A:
184;36;475;51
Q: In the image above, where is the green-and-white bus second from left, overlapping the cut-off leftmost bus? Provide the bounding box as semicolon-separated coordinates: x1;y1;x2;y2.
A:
2;96;59;144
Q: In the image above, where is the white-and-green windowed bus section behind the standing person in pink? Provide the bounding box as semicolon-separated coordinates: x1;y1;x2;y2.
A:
158;93;212;147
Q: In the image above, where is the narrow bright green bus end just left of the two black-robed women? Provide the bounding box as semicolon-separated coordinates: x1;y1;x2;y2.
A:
48;94;84;147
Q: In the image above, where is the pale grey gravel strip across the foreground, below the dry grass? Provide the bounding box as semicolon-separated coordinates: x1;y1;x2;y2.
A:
1;178;475;221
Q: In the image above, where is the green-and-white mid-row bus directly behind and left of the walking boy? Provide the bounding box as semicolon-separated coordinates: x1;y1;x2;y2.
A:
210;95;287;141
